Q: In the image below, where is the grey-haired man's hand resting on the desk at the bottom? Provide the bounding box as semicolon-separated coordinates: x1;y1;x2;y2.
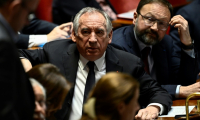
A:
135;105;160;120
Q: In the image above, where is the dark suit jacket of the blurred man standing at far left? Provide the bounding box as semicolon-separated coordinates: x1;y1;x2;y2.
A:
0;18;35;120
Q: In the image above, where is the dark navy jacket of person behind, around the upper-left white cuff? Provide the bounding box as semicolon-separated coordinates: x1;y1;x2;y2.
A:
14;18;57;49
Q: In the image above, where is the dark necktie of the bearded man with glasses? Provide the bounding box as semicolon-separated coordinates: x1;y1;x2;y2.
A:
142;47;151;74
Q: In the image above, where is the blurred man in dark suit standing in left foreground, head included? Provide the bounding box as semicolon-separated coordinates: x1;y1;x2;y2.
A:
0;0;38;120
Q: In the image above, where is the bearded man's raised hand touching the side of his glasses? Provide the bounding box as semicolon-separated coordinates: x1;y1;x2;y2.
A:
169;15;192;46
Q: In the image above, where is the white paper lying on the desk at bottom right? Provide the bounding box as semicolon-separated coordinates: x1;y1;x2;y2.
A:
159;106;195;117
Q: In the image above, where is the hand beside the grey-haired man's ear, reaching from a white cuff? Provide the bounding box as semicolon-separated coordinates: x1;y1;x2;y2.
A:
47;22;73;42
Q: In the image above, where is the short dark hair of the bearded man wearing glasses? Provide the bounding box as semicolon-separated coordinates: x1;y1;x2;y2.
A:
136;0;173;17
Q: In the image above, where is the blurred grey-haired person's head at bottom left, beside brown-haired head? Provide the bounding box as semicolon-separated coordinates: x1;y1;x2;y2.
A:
30;78;46;120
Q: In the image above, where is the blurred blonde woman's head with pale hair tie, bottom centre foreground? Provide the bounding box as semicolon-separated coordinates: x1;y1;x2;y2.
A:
81;72;140;120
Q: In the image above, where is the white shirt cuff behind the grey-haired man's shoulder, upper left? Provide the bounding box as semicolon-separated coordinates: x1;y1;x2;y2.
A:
28;35;47;48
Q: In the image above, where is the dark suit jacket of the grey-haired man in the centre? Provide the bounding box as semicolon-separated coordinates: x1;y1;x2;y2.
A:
19;40;172;120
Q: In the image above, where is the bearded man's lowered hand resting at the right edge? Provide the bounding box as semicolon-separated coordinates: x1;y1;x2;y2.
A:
179;82;200;98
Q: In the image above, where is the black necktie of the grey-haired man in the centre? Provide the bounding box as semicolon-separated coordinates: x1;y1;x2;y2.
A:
83;61;95;103
